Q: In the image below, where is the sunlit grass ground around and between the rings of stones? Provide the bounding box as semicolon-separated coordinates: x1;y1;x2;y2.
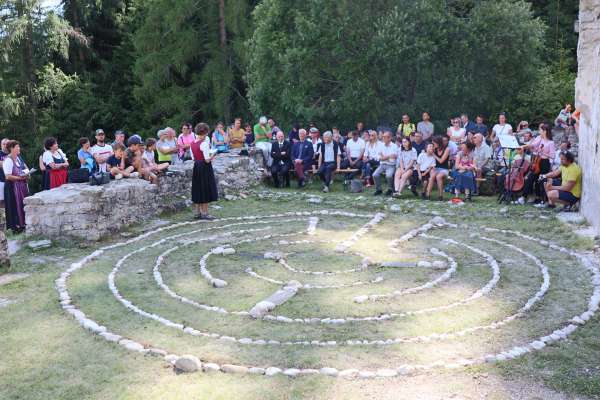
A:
0;184;600;400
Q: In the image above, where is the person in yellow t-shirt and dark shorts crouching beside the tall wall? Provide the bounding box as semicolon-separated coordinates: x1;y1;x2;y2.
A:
536;151;581;211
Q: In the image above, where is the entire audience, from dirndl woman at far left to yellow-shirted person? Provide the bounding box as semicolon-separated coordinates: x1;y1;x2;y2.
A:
0;105;581;231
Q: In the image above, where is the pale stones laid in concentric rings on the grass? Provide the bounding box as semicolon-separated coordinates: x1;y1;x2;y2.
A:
51;210;600;379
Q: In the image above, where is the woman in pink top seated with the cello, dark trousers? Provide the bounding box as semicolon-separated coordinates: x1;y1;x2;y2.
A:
517;123;556;204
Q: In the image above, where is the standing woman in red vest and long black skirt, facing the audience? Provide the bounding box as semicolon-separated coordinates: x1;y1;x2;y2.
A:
190;122;219;220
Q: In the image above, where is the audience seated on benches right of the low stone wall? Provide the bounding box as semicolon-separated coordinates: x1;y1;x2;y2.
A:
236;110;581;206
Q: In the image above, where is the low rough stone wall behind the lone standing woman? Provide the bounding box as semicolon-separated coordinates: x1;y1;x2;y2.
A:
25;154;263;240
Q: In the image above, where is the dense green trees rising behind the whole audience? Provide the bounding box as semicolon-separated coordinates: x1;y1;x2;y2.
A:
0;0;577;161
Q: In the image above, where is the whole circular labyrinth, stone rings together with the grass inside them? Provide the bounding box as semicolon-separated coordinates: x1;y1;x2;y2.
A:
56;210;600;378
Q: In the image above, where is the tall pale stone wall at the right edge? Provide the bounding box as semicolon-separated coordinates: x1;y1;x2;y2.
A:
575;0;600;231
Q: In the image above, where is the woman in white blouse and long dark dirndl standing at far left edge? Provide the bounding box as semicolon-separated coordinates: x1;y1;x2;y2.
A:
2;140;29;233
